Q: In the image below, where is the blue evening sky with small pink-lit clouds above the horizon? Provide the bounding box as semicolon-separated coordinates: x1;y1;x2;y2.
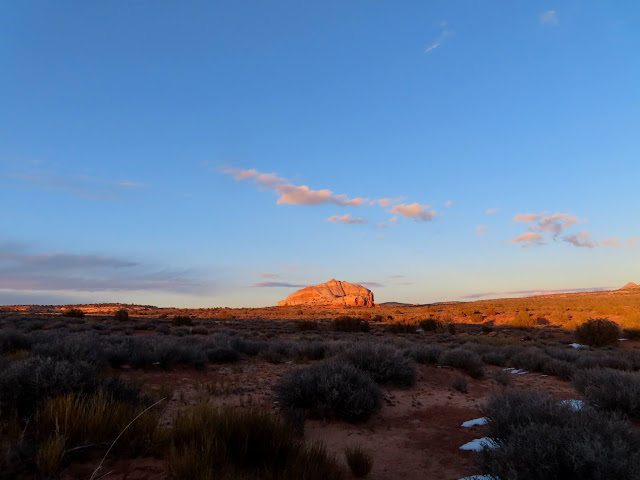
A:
0;0;640;307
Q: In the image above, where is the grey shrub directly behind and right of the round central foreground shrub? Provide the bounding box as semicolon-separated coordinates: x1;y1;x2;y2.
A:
343;343;418;387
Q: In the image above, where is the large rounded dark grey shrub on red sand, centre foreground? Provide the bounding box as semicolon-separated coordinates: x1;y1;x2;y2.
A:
274;362;382;422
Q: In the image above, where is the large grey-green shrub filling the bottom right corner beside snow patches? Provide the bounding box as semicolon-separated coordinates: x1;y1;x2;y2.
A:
475;391;640;480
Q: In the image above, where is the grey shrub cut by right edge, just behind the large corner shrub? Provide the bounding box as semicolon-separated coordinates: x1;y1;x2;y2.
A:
573;368;640;418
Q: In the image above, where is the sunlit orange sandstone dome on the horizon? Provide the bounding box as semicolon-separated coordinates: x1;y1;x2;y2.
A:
278;278;375;307
